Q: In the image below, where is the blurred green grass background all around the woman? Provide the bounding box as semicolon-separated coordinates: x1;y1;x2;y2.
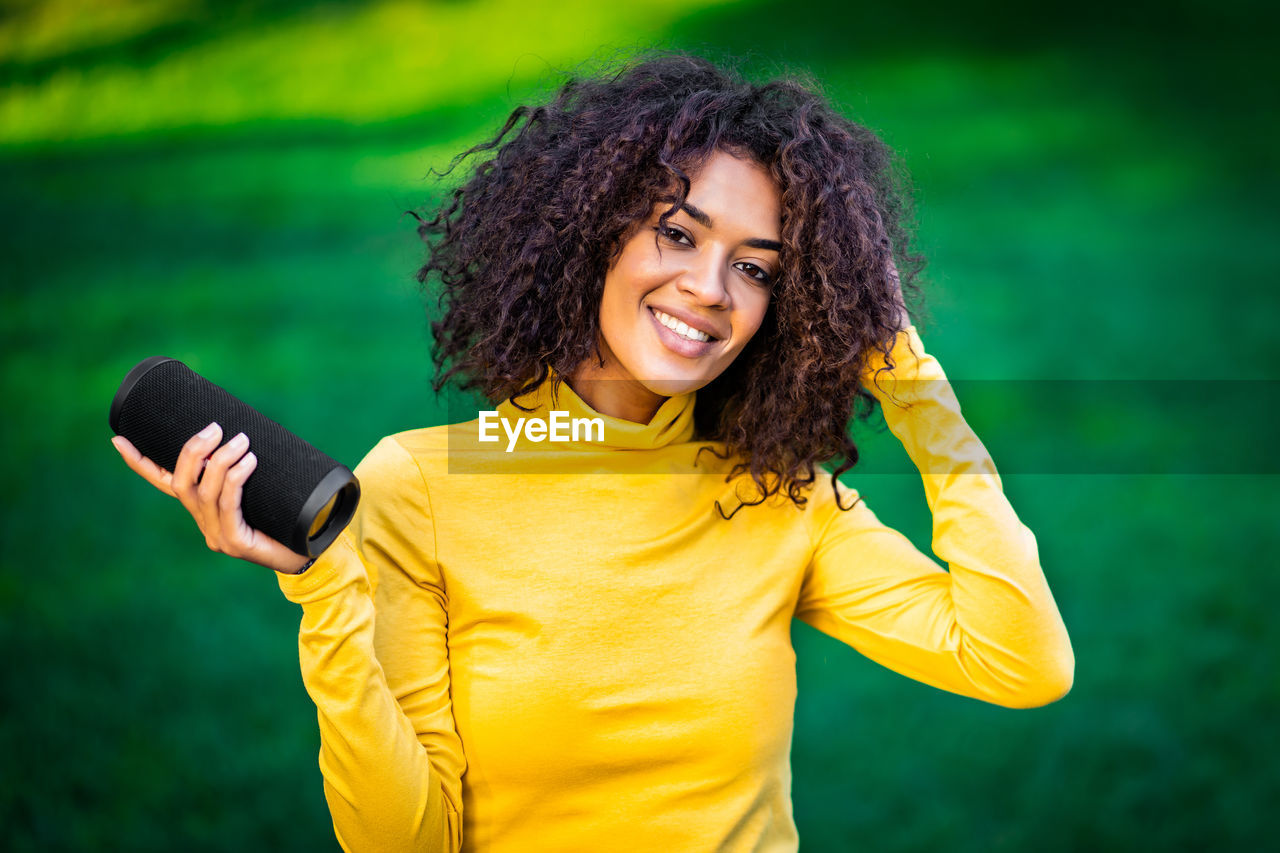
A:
0;0;1280;852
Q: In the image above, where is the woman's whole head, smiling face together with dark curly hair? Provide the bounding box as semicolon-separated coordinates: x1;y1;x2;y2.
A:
419;56;923;507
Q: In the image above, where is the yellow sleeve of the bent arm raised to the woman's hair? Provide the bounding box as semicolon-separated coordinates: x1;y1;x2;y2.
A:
796;328;1074;707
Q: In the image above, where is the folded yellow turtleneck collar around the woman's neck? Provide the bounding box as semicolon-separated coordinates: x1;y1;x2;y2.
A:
498;374;696;450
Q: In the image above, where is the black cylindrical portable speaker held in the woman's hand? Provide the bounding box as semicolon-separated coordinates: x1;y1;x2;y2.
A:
110;356;360;557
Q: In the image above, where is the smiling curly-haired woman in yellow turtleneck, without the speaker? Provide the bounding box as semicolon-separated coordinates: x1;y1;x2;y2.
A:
115;56;1074;852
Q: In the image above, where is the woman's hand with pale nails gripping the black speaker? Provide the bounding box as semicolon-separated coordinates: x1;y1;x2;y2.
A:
111;424;308;575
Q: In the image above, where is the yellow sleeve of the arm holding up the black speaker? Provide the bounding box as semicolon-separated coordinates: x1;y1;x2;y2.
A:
279;438;465;853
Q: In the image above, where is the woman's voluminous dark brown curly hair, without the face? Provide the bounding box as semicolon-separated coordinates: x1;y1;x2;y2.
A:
417;54;923;515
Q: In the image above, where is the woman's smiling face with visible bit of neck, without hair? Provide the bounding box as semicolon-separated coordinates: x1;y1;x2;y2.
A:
571;151;782;423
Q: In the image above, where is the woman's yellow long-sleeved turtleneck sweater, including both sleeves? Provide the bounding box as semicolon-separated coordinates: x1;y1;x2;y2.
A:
279;329;1074;853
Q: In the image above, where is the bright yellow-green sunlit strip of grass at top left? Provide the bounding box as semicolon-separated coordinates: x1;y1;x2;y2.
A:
0;0;742;143
